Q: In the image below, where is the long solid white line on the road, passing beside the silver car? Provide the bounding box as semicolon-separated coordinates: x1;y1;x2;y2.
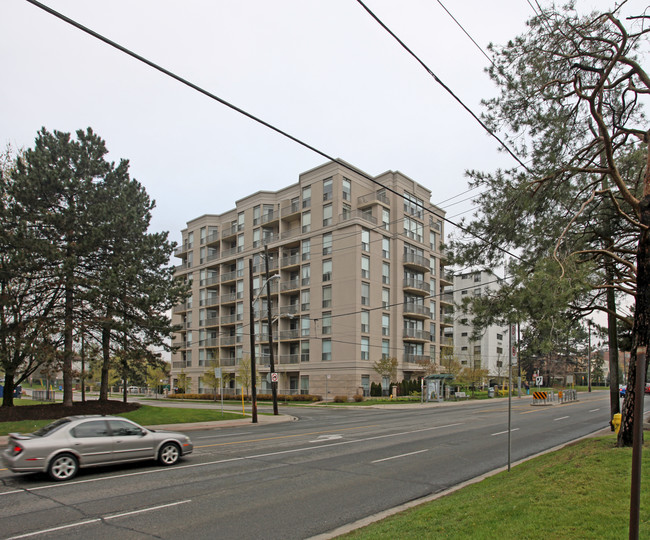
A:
0;422;464;496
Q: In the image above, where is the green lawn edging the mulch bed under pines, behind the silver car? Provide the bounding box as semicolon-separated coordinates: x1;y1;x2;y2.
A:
0;400;242;435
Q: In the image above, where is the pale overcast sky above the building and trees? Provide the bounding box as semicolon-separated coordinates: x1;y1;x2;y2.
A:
0;0;647;245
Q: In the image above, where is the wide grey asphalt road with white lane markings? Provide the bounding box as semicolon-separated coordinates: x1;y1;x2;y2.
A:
0;392;624;540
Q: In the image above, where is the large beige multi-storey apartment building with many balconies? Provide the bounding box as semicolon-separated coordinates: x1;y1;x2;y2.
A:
172;162;451;399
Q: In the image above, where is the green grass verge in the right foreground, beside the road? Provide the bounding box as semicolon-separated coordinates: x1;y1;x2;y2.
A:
340;431;650;540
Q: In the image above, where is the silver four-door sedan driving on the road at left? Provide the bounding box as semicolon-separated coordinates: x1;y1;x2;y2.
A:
2;415;194;481
